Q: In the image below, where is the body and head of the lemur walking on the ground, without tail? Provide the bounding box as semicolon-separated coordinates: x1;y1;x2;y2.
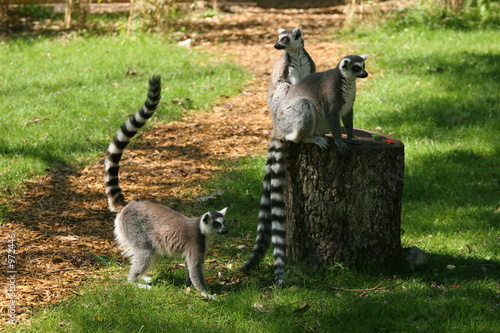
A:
115;200;228;293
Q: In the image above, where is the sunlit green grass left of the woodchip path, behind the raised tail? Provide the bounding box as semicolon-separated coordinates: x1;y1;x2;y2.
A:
0;34;249;215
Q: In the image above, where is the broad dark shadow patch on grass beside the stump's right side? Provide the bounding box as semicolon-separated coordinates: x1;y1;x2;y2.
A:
404;147;500;211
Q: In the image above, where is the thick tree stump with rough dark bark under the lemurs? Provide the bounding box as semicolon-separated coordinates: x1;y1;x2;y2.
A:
286;130;404;269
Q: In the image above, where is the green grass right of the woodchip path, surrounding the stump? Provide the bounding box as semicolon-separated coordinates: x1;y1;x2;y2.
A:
3;11;500;333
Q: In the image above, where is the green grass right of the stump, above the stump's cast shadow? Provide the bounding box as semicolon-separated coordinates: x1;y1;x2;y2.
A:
356;28;500;259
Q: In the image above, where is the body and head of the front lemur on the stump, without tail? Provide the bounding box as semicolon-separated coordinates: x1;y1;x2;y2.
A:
276;55;368;153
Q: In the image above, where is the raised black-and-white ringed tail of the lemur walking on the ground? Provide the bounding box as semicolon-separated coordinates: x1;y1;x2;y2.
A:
104;75;161;212
